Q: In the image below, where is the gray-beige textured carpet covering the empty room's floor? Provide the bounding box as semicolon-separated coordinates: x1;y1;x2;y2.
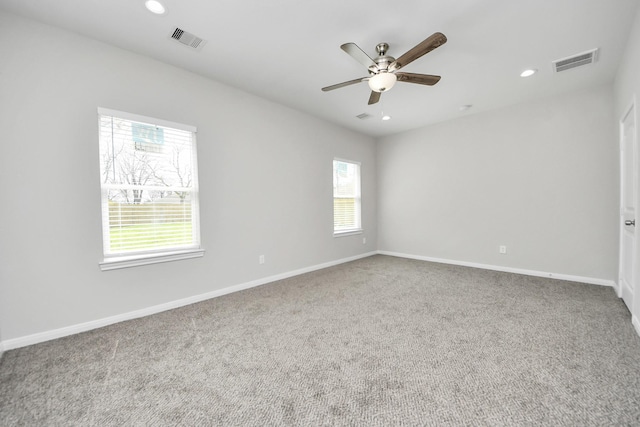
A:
0;256;640;426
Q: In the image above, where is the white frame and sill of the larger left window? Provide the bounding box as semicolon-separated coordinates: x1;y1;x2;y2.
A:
97;107;205;271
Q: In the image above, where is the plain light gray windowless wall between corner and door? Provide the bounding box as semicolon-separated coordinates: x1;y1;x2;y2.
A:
378;85;619;280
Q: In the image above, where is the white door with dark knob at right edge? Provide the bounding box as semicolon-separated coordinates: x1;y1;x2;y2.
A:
619;105;640;311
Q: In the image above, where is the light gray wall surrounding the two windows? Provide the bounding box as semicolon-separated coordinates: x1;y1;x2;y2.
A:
0;13;377;340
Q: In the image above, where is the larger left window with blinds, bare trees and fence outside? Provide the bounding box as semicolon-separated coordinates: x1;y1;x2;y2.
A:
98;108;203;270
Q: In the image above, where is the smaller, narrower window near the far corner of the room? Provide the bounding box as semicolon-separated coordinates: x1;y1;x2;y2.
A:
333;159;362;235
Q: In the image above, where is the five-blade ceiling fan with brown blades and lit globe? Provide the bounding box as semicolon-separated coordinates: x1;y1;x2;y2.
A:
322;33;447;105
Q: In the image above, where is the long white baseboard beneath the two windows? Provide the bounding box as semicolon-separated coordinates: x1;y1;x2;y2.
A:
0;251;377;353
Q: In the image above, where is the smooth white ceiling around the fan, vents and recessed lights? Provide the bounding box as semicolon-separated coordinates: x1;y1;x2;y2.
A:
0;0;640;136
